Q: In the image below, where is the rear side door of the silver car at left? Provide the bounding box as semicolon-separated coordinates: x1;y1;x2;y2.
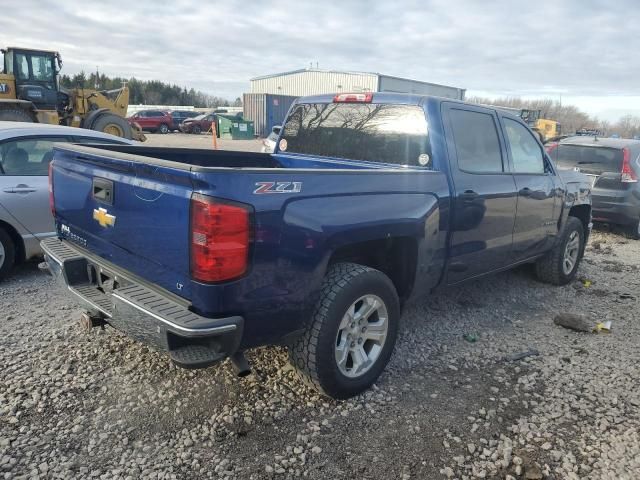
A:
0;136;71;235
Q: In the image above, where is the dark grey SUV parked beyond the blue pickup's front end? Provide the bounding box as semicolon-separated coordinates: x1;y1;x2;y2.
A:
547;136;640;239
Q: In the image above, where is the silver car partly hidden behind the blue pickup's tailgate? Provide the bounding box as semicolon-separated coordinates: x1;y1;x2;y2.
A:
0;122;135;280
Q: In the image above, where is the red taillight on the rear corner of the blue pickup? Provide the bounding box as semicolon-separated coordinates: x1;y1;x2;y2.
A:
191;193;250;282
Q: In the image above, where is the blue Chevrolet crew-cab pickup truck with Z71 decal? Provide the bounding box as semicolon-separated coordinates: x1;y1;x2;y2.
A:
42;93;591;398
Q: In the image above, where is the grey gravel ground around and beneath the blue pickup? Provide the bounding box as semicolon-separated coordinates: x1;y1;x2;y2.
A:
0;232;640;480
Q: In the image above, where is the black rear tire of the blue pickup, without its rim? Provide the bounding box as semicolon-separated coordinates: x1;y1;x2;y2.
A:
289;263;400;399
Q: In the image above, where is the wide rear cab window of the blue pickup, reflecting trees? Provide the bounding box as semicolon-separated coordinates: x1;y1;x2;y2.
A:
280;103;431;167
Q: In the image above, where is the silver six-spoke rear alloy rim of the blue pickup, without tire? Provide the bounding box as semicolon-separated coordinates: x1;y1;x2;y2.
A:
335;295;389;378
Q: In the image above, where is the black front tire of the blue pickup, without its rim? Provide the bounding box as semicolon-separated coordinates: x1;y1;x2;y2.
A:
536;217;584;285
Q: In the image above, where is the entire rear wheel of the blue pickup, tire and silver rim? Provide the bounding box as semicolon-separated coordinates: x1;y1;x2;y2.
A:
289;263;400;398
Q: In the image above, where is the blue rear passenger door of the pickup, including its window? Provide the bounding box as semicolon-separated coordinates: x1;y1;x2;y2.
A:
443;103;517;283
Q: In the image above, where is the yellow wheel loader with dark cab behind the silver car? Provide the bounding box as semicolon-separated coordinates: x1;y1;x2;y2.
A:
0;47;145;141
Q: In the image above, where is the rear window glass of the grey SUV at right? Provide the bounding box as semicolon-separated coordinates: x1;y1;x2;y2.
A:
551;144;622;175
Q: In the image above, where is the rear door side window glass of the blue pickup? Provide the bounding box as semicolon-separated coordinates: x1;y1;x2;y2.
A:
449;108;504;173
